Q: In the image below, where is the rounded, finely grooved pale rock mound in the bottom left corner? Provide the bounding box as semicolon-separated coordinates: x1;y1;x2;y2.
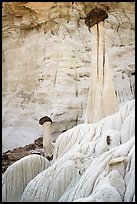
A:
2;155;50;202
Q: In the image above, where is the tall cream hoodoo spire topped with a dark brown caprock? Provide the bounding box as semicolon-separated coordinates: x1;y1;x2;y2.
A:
85;8;118;123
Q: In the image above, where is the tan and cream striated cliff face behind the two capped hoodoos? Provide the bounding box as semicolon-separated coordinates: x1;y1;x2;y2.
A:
2;2;135;151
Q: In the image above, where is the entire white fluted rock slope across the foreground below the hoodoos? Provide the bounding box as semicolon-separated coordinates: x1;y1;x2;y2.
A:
3;100;135;202
